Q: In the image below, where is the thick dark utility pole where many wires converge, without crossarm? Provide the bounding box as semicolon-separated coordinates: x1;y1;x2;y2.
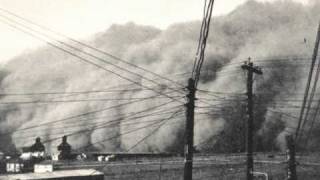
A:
184;78;196;180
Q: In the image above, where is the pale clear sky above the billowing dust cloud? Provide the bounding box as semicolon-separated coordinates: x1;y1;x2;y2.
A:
0;0;308;64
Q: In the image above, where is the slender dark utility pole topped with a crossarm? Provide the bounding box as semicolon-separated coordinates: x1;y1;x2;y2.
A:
241;58;262;180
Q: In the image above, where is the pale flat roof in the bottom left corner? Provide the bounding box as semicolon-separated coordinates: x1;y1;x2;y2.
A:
0;169;104;180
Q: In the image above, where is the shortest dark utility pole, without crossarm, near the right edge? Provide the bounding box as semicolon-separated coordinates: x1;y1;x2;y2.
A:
286;135;297;180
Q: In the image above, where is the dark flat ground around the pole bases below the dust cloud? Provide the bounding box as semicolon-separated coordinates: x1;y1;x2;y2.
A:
52;154;320;180
